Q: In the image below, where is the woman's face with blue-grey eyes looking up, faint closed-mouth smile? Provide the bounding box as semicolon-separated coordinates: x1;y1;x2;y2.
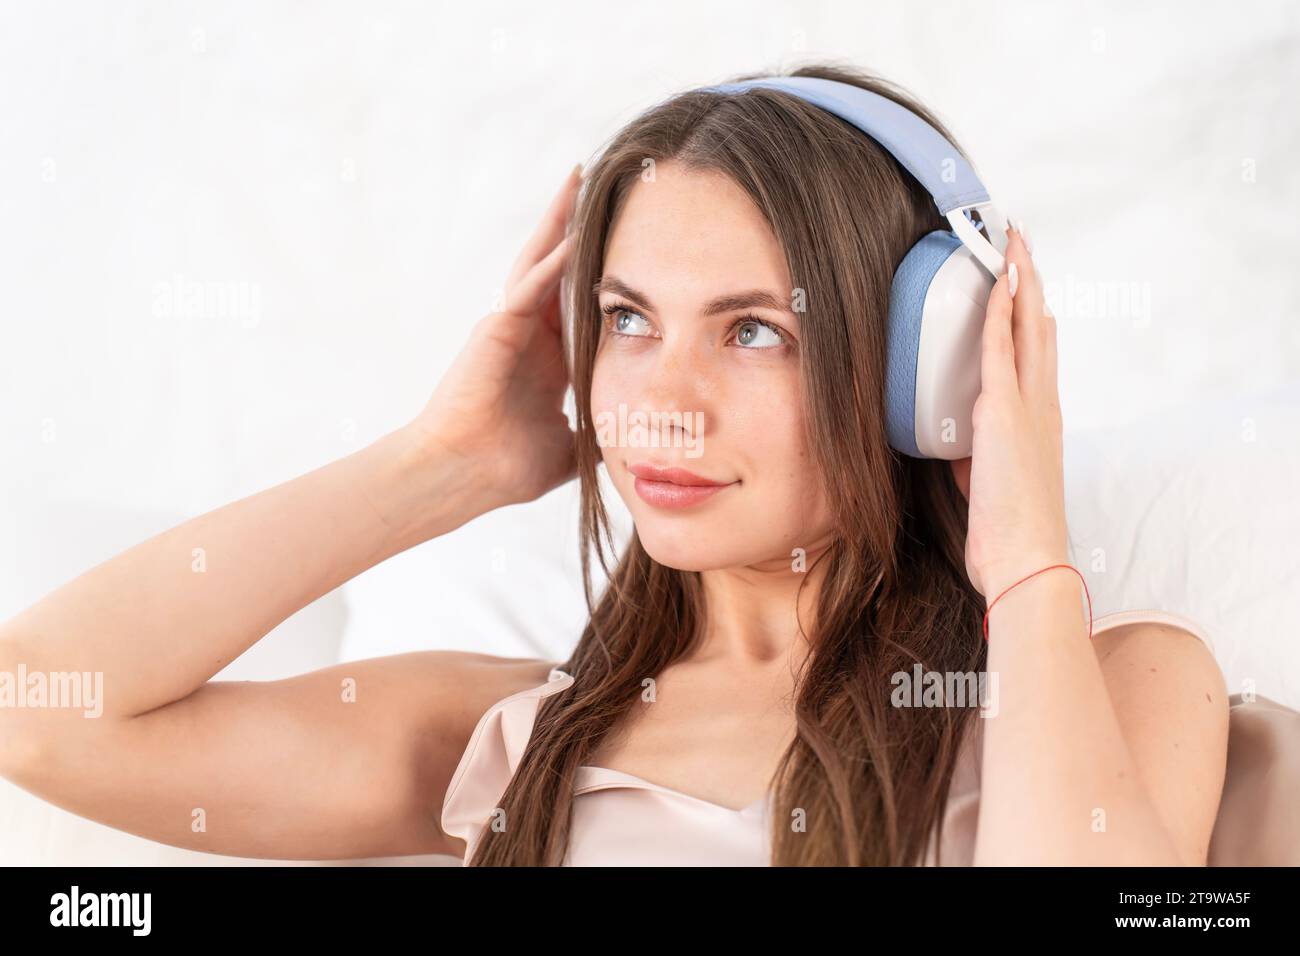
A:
592;163;829;571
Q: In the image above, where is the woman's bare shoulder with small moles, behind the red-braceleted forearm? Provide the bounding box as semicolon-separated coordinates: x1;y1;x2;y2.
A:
1095;622;1230;866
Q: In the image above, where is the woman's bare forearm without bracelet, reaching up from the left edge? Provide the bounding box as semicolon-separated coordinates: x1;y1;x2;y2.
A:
0;429;480;717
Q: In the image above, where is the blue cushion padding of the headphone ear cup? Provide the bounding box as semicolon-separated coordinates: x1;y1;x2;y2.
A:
885;229;962;458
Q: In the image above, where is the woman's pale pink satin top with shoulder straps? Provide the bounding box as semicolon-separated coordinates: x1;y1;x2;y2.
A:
441;610;1300;866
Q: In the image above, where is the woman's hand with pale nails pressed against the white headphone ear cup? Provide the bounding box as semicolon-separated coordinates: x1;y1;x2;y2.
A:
953;222;1070;601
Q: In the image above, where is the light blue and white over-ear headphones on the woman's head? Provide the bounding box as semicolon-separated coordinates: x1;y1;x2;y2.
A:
702;77;1006;460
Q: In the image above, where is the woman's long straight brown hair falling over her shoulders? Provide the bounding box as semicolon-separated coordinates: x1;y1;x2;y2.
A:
468;64;985;866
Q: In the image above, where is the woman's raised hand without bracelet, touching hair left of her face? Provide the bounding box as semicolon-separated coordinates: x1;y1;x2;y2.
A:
411;166;581;509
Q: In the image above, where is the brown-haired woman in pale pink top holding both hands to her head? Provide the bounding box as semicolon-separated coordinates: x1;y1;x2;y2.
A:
0;61;1229;865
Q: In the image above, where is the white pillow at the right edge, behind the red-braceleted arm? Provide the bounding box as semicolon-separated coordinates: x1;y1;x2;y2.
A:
1065;382;1300;708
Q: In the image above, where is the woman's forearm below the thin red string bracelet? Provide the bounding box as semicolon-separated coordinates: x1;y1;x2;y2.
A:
975;570;1182;865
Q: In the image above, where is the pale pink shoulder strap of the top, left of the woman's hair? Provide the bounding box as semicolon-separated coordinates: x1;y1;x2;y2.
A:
441;667;573;857
